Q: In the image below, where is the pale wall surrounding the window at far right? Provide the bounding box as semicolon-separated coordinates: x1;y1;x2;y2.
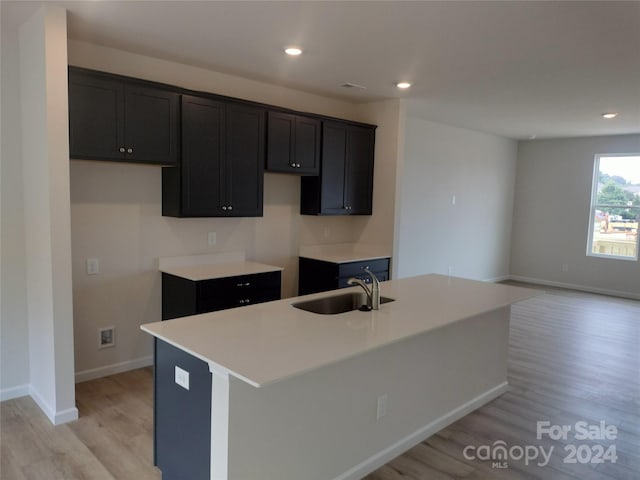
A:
511;135;640;298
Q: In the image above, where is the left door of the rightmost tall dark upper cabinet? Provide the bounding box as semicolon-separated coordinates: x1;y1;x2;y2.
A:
319;122;348;215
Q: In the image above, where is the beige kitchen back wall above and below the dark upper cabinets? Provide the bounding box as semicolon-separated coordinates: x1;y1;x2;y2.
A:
69;41;372;379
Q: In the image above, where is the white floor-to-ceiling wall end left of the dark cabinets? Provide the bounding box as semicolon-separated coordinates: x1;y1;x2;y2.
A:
19;6;78;424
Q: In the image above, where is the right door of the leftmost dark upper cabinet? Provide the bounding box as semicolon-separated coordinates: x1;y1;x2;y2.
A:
125;85;179;165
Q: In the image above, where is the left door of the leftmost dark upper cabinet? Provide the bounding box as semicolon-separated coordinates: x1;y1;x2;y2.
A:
69;70;125;160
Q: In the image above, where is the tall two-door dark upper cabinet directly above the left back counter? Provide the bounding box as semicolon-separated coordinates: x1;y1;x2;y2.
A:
162;95;265;217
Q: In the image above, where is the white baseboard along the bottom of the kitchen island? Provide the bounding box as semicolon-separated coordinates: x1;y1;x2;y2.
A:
334;382;509;480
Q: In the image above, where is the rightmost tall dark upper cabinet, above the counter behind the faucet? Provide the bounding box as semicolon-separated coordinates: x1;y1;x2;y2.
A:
300;121;375;215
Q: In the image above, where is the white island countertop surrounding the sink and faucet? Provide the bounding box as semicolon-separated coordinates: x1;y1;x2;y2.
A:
141;275;541;387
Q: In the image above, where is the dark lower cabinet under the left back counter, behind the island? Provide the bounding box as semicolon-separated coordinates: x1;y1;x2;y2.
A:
162;271;282;320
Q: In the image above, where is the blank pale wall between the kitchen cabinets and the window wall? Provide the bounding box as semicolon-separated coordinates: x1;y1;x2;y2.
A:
394;116;517;280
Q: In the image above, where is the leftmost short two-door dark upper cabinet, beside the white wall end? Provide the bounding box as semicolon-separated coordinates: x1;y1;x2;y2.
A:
69;68;179;165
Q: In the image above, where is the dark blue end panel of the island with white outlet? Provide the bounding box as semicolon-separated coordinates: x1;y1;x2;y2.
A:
153;338;211;480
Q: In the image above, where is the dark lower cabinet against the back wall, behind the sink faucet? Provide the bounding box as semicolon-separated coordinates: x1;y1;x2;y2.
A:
298;257;389;295
